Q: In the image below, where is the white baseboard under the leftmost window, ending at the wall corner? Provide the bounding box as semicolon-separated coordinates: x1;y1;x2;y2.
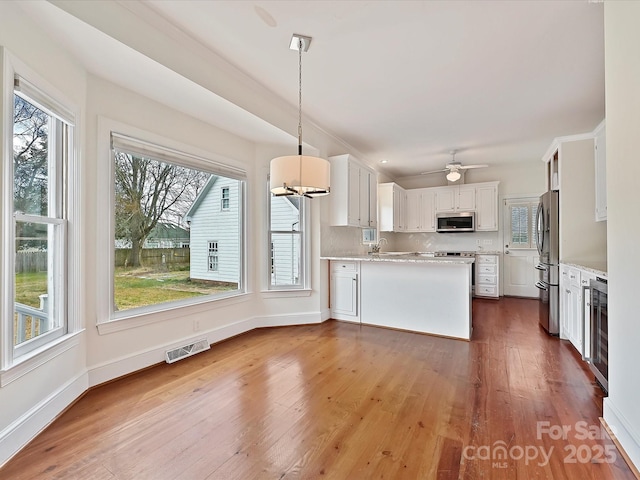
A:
0;372;89;467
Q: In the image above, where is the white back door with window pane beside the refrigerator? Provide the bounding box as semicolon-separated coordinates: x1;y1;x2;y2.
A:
502;197;538;298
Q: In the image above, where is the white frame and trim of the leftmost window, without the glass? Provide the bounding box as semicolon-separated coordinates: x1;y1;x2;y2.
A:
0;47;84;378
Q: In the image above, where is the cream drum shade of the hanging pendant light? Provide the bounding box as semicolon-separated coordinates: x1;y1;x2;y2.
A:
269;155;331;197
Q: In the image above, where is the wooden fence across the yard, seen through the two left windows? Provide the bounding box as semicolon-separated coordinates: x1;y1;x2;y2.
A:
16;248;190;273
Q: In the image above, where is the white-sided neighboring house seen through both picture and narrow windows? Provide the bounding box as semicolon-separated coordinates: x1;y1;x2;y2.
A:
185;175;301;285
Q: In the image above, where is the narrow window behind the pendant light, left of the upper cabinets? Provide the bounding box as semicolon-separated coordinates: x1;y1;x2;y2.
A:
267;184;308;290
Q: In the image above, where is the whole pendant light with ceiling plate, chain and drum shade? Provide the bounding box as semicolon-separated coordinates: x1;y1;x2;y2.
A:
269;34;330;197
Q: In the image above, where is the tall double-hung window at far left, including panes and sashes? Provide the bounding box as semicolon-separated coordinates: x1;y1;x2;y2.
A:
2;75;75;361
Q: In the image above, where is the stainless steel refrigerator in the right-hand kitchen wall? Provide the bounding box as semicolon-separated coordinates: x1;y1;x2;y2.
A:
535;191;560;335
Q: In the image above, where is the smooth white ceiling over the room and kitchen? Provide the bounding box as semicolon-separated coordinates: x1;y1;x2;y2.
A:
26;0;604;177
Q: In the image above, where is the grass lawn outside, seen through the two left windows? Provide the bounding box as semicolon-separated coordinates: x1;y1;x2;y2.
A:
16;268;237;310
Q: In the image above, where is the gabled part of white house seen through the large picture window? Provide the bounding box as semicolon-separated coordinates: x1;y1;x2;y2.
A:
185;175;241;283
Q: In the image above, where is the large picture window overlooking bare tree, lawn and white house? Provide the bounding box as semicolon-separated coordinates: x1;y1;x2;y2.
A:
112;133;244;318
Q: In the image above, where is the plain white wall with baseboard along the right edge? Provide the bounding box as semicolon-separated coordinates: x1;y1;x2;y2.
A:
604;2;640;467
